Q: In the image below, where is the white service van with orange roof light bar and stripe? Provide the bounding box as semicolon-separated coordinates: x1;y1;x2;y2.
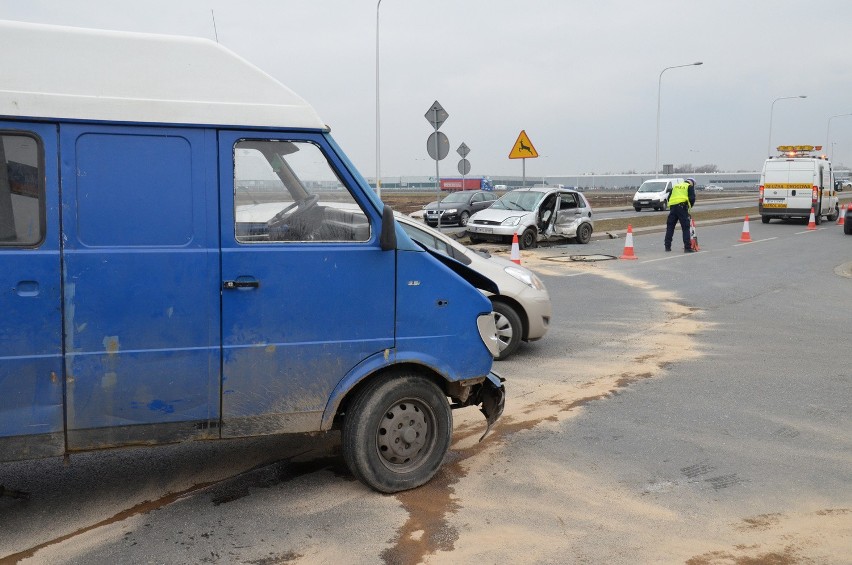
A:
758;145;840;224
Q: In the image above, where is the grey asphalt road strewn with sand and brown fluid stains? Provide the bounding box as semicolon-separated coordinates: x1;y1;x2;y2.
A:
0;217;852;565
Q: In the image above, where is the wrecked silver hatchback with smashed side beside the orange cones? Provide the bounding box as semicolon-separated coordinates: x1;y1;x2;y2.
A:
467;186;595;249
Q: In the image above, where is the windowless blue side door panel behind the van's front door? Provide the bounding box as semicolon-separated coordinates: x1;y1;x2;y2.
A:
60;124;220;450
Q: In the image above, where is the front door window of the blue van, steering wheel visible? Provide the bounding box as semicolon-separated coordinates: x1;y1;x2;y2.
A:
234;140;370;243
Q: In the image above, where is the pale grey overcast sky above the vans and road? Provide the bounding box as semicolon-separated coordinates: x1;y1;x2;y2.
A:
0;0;852;179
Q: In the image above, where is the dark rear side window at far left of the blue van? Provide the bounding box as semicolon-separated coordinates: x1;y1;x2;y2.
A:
0;133;45;247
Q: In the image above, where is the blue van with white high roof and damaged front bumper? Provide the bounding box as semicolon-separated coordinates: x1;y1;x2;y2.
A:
0;22;504;492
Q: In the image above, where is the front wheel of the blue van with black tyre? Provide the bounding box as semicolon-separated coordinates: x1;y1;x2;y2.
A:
342;374;453;493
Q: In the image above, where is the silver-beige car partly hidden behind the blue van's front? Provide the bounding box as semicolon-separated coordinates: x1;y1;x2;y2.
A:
396;214;552;360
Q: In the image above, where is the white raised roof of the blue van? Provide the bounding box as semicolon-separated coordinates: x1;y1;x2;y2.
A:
0;20;325;129
